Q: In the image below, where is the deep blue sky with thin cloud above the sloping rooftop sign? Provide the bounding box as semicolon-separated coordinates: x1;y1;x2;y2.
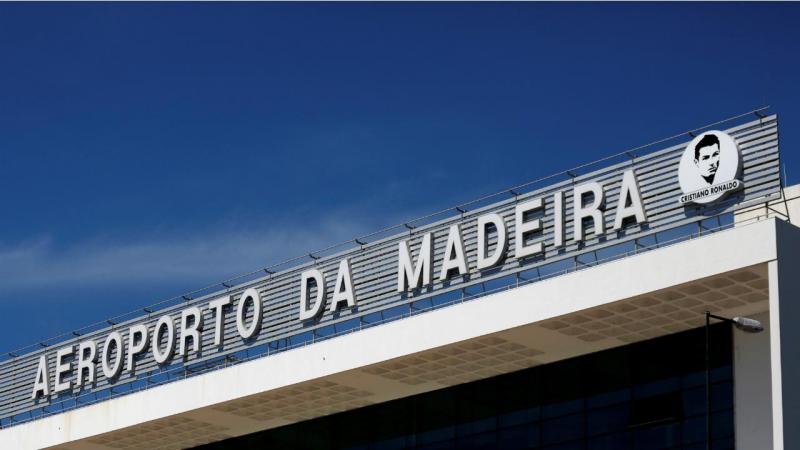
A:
0;3;800;350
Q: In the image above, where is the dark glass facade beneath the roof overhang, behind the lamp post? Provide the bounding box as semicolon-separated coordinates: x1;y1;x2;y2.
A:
194;324;735;450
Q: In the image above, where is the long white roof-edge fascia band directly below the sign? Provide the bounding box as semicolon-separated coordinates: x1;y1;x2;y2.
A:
0;220;788;449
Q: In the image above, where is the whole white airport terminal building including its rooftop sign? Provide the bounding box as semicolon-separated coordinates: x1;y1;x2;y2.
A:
0;110;800;450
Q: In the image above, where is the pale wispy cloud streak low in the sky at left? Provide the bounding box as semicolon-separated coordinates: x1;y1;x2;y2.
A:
0;220;364;291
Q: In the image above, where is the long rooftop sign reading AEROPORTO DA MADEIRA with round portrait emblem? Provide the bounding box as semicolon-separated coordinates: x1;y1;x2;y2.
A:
0;112;780;426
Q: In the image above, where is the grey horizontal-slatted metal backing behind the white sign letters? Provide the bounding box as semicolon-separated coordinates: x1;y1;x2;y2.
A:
0;115;780;417
